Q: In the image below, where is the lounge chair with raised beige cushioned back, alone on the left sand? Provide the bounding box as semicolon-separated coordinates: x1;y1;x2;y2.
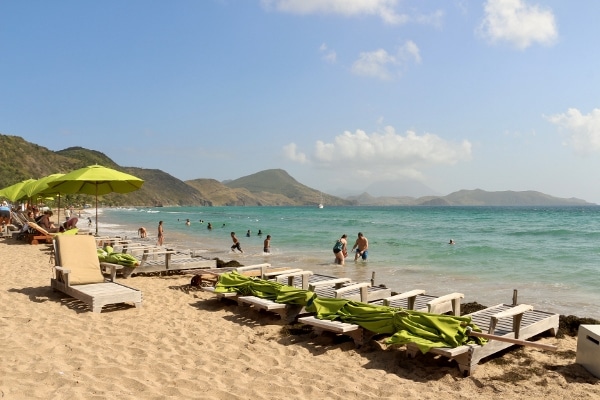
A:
50;235;142;313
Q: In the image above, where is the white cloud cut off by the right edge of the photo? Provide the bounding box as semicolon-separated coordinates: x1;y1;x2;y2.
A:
547;108;600;154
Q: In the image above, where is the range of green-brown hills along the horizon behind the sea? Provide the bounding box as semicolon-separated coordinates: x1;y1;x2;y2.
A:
0;134;591;207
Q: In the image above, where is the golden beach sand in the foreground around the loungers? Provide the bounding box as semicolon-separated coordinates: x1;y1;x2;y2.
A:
0;239;600;399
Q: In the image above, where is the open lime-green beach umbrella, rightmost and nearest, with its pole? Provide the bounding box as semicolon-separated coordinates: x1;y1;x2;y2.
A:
46;165;144;235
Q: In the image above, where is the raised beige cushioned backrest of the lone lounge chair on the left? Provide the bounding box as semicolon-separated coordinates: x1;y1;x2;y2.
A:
55;235;104;285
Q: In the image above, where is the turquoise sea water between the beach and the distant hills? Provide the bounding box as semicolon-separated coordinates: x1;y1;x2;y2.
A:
99;206;600;319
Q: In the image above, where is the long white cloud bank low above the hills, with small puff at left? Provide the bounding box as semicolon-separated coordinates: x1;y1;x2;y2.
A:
286;126;472;179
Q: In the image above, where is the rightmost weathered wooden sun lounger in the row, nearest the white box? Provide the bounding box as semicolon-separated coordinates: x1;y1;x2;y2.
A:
406;304;559;376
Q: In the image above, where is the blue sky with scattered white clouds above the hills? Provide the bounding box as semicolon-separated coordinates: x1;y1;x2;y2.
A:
0;0;600;203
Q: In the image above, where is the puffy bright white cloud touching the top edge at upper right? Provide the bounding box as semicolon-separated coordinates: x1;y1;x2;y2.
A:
479;0;558;50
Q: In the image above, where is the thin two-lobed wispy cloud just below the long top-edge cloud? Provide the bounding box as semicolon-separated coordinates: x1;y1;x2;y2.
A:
352;40;421;80
